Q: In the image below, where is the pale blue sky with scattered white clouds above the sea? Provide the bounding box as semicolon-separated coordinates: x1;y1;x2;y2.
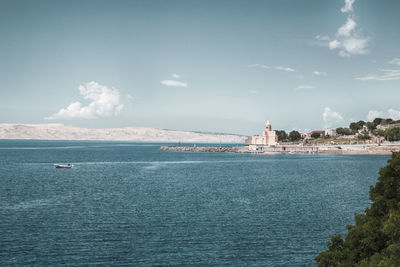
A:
0;0;400;135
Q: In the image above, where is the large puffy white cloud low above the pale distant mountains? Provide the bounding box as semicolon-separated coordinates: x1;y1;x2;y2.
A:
45;81;123;120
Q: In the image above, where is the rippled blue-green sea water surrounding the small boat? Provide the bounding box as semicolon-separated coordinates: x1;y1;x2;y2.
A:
0;141;389;266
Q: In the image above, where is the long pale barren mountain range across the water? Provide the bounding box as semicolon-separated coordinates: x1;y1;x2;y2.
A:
0;123;247;143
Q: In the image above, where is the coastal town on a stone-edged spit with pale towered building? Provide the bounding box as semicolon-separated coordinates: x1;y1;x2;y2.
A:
160;118;400;155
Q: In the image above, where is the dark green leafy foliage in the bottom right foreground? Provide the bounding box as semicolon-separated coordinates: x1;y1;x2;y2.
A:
315;152;400;267
